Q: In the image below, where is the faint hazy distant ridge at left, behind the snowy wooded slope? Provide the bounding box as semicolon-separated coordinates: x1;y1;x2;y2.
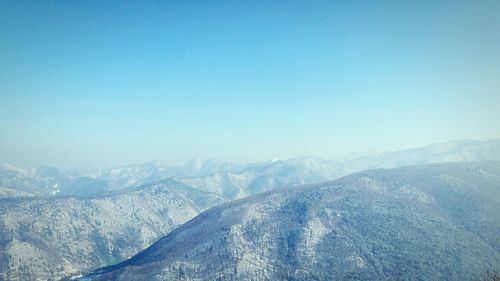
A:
0;159;243;198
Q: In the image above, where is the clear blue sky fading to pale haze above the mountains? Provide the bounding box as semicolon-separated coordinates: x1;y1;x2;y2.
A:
0;0;500;168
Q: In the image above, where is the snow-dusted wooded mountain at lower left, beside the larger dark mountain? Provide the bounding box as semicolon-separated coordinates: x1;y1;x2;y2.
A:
0;179;222;280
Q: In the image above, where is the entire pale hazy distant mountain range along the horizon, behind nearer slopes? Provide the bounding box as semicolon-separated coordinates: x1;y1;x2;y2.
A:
0;140;500;199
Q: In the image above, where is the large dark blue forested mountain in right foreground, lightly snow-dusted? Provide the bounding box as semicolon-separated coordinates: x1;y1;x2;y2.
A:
80;162;500;281
